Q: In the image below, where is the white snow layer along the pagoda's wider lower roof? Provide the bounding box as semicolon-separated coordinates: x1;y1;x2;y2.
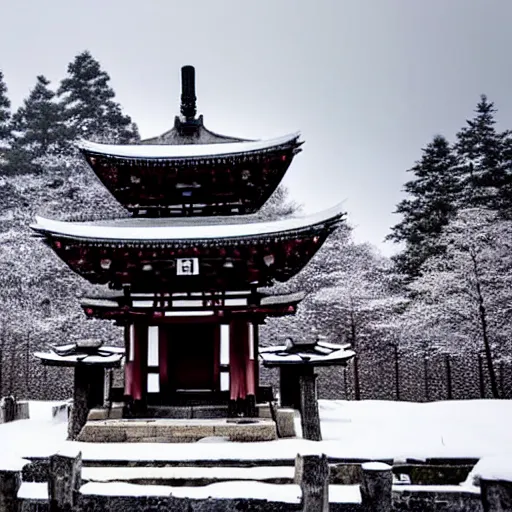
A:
31;204;343;241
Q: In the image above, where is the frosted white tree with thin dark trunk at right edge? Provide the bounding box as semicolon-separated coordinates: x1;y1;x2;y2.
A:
405;208;512;398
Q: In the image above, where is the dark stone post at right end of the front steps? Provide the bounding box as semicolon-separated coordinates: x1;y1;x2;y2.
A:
295;454;329;512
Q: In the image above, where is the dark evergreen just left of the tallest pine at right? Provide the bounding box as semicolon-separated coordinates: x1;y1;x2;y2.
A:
387;135;459;278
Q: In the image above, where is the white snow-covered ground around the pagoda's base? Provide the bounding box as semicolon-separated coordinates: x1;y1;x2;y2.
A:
0;400;512;467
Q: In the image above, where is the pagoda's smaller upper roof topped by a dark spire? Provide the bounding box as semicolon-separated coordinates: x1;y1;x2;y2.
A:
78;66;302;217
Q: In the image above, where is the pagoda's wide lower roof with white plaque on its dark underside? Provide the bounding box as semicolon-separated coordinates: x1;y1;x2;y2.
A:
31;205;344;292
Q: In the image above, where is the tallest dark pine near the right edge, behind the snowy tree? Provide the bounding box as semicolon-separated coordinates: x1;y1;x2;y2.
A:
455;95;508;211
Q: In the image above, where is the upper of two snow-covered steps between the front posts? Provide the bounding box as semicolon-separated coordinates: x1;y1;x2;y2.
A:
82;466;295;487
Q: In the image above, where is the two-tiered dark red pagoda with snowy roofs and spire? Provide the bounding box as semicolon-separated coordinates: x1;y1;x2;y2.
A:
32;66;343;424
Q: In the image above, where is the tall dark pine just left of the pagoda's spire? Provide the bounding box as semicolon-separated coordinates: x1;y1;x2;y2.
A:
57;51;139;143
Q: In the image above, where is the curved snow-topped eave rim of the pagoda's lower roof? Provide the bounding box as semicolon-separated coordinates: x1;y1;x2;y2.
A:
30;204;345;245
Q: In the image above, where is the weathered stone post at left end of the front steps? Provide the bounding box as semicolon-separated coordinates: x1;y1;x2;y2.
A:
48;452;82;512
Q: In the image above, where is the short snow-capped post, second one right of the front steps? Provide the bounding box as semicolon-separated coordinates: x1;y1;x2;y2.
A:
361;462;393;512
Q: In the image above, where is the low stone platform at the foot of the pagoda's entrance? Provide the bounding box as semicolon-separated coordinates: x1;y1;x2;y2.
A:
77;418;277;443
